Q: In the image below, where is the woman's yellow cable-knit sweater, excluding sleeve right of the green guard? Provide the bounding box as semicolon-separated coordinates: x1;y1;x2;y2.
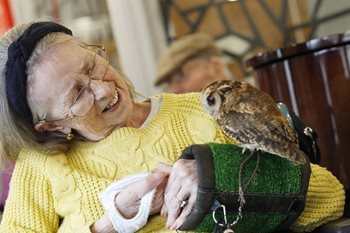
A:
0;93;232;233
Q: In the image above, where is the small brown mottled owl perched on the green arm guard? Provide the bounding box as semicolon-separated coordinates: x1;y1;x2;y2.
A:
201;80;306;164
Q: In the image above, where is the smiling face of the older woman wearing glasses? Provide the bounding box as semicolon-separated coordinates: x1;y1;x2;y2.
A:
28;40;146;140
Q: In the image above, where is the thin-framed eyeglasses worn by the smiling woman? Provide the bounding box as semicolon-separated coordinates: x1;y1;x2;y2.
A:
38;45;109;122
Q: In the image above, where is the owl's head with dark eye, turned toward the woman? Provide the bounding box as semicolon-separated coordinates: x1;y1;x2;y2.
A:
201;80;233;119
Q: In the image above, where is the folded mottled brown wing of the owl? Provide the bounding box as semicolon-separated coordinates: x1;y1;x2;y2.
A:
223;89;298;143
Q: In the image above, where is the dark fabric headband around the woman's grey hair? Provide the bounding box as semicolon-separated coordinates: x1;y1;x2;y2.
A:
5;22;72;124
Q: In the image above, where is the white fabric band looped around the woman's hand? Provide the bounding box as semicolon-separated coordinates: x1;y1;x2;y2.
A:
99;173;156;233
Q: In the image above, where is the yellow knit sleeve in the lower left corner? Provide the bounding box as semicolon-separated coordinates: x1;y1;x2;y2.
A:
0;152;59;233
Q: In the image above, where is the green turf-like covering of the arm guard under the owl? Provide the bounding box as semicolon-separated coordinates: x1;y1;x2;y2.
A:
195;143;302;233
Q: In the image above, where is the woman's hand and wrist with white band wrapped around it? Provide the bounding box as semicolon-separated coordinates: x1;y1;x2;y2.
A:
90;170;169;233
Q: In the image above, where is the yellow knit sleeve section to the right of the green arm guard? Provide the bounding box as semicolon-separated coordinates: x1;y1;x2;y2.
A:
290;164;345;232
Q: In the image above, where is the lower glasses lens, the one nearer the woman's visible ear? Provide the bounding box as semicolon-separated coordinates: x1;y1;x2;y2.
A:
71;88;94;117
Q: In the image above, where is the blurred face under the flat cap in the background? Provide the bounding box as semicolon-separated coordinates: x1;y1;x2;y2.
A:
167;58;224;93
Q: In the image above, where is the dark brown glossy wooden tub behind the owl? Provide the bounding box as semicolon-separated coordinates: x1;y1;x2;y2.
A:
246;33;350;186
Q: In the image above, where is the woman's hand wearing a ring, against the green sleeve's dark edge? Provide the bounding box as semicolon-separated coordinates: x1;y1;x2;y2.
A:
158;159;198;230
